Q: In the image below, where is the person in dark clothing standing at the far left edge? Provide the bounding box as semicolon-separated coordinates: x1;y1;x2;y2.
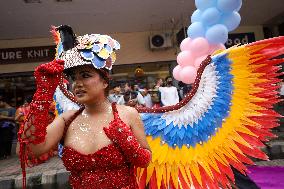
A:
0;96;16;159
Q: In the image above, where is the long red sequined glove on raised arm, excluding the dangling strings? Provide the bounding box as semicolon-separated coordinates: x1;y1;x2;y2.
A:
20;60;64;144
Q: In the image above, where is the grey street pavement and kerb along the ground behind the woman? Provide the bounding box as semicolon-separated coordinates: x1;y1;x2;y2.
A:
0;156;284;189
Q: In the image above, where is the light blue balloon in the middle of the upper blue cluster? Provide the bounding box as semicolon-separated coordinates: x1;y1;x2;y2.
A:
201;7;221;26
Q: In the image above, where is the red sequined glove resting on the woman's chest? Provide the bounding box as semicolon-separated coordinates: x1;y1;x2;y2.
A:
104;121;151;167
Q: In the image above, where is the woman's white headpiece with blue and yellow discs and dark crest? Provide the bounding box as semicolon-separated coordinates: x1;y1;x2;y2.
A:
51;25;120;70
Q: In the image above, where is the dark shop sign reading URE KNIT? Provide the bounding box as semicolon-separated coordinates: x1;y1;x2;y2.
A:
0;46;55;65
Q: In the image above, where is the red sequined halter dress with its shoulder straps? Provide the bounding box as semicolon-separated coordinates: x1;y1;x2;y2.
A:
62;104;138;189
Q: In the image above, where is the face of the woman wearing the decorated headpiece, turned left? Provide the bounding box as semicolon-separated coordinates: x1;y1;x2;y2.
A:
70;65;108;104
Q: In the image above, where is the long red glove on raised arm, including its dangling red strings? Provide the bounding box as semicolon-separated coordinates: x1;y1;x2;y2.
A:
18;60;64;189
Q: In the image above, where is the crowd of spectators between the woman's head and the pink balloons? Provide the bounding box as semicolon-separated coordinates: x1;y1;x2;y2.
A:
108;76;191;108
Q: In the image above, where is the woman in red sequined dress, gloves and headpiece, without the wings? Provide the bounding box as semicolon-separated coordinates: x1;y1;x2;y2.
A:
18;26;151;189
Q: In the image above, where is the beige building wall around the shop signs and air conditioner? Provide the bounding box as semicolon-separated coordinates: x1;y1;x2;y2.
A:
0;26;264;73
